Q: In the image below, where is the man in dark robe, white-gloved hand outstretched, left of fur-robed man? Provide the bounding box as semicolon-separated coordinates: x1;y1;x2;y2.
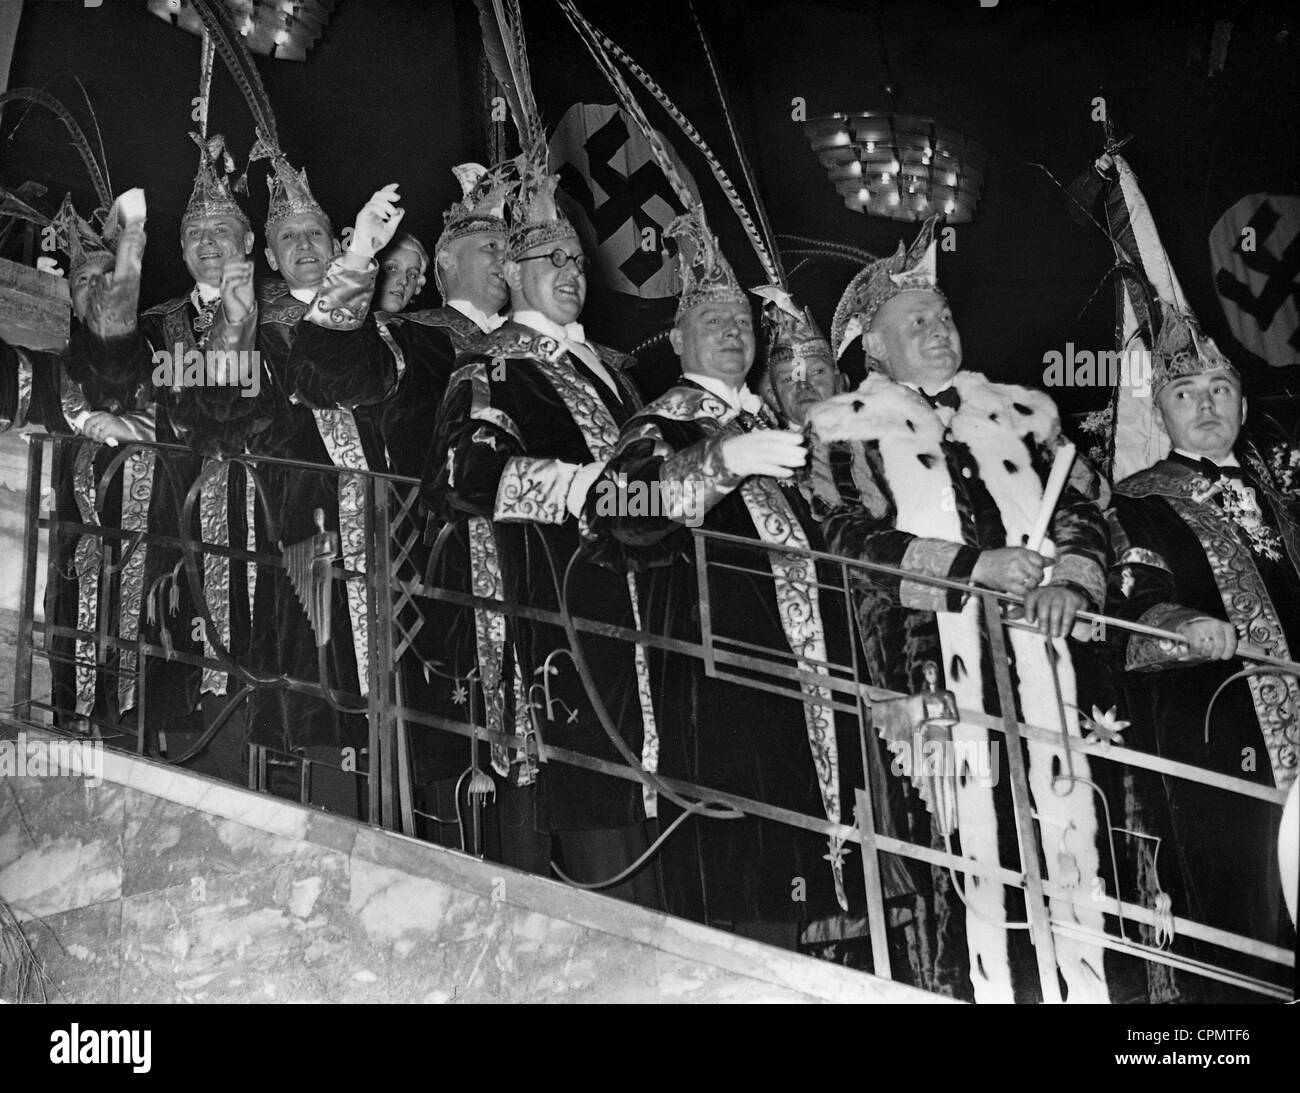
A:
586;211;863;947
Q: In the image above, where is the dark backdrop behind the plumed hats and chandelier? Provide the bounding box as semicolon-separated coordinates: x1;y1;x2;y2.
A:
0;0;1300;409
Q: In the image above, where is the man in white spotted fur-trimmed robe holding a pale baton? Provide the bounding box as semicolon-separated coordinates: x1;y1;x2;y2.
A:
809;225;1114;1002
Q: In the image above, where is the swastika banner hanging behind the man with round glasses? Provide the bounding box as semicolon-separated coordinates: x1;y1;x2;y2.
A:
550;103;698;299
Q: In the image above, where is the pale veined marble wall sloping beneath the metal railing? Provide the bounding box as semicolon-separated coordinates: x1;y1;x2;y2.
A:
0;727;936;1002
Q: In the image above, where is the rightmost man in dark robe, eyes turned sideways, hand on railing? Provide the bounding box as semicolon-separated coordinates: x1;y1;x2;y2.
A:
1106;307;1300;971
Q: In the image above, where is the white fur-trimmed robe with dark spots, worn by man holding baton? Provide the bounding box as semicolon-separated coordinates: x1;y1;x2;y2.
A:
810;372;1113;1002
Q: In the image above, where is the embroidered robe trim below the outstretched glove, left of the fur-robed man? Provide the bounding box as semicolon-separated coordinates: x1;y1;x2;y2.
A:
740;477;849;911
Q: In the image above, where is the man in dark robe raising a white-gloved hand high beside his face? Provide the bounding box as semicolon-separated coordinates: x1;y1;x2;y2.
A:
241;170;400;815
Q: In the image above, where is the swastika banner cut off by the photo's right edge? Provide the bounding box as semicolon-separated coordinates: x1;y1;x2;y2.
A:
1210;194;1300;366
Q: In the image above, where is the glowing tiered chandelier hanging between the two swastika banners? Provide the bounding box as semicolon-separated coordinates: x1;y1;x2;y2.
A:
803;112;985;224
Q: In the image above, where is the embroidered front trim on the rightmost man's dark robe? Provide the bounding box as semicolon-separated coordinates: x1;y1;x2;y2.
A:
1166;496;1300;789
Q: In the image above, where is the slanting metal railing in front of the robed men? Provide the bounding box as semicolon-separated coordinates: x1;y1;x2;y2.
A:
14;435;1295;1002
